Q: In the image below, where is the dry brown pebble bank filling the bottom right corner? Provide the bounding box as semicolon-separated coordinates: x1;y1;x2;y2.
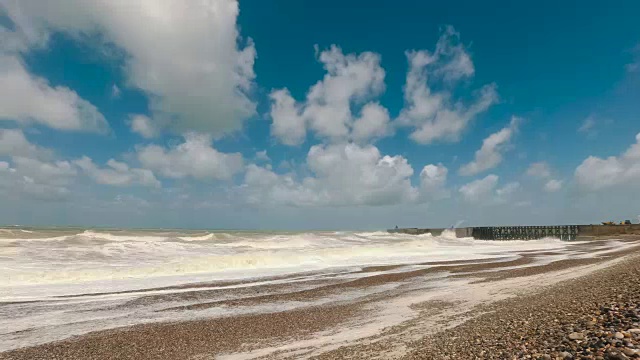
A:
405;246;640;359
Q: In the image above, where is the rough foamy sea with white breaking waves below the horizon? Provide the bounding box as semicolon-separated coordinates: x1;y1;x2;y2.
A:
0;227;565;302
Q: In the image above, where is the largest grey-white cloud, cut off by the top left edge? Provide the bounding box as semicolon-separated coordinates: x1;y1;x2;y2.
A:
0;0;256;134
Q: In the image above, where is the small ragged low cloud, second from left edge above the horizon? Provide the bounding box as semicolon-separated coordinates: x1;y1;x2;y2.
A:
74;156;161;188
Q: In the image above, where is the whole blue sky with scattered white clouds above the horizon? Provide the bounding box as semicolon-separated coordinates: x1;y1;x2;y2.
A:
0;0;640;230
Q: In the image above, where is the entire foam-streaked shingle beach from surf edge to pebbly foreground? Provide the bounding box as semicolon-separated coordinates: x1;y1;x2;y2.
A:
0;232;640;359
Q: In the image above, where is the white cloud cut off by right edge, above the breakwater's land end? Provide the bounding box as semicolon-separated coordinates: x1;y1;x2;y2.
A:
575;133;640;191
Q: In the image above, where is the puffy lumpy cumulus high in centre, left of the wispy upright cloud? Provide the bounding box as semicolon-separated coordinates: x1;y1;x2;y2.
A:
270;45;389;145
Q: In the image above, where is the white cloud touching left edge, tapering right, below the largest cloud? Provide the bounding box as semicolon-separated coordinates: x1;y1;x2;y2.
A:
0;56;109;132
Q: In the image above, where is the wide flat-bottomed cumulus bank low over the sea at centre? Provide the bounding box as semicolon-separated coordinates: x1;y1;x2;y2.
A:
239;143;448;206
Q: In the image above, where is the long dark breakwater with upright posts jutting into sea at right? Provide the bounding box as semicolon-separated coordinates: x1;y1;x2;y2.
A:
388;224;640;241
